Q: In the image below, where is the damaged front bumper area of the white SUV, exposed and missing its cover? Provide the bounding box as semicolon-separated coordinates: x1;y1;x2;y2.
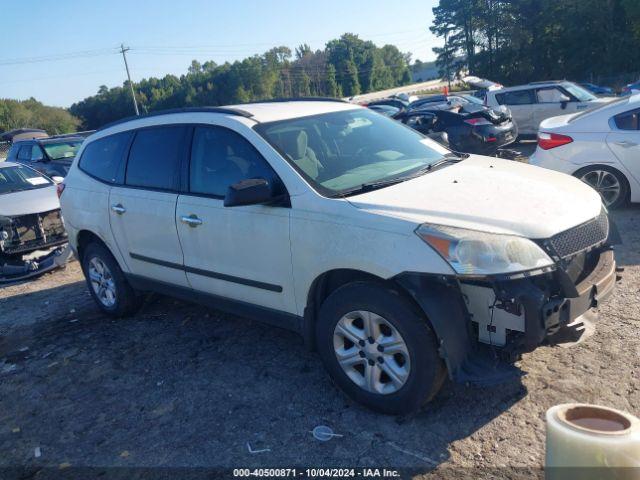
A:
396;247;618;385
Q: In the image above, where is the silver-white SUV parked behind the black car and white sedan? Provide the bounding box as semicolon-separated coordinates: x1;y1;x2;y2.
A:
485;81;615;135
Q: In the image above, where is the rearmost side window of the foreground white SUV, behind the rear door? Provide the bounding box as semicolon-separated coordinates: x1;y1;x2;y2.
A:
78;132;131;183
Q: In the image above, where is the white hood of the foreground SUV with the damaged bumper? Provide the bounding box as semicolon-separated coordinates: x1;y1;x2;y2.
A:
348;155;601;239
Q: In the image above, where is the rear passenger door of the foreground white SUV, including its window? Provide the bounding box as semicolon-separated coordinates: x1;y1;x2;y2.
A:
109;125;189;287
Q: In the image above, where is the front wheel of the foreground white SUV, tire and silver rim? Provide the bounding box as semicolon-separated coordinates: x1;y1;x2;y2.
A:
316;282;446;414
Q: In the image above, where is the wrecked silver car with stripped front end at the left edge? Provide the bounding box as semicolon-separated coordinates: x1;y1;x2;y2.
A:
0;162;71;283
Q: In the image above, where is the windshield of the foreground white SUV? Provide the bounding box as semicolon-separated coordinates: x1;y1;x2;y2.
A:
254;109;449;196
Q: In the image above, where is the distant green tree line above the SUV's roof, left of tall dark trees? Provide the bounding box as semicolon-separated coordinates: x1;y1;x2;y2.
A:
69;33;411;129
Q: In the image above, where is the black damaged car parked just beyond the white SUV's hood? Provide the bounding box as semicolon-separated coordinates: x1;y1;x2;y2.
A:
402;99;518;156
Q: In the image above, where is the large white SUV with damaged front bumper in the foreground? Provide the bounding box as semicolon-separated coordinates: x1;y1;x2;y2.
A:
60;100;616;413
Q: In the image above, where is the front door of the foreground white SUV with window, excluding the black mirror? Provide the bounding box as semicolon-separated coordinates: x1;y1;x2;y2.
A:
176;125;296;313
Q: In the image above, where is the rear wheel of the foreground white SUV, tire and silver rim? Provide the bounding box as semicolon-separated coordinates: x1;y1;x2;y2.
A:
82;242;142;317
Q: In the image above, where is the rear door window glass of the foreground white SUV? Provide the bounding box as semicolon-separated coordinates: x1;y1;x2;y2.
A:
125;126;187;190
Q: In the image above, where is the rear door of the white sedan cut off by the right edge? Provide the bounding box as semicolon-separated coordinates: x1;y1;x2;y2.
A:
607;109;640;186
